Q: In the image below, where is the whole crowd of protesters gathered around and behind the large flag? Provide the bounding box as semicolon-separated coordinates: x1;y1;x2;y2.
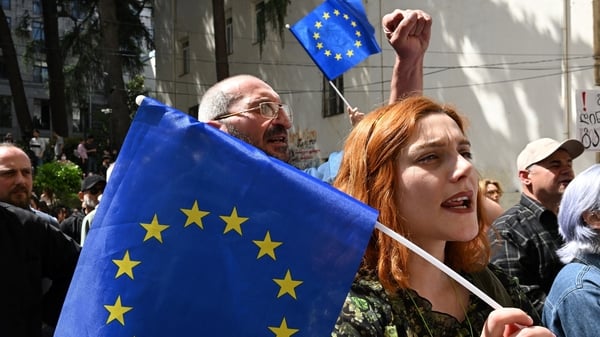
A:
0;4;600;337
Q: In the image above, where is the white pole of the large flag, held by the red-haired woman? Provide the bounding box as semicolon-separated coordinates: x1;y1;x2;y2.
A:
375;221;502;309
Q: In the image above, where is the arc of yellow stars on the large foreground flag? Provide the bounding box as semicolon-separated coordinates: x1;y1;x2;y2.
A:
104;200;303;337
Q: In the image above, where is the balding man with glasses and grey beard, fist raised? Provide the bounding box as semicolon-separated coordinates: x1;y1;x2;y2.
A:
198;10;431;182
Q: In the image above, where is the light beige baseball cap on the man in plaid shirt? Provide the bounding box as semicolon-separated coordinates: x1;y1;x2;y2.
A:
517;138;585;171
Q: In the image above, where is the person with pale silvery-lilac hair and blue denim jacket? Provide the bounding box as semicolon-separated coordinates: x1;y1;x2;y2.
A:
542;164;600;337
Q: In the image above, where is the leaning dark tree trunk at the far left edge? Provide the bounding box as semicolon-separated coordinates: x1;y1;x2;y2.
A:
0;6;33;136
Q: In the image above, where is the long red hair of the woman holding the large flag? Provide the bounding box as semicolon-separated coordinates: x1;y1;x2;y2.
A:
334;96;490;290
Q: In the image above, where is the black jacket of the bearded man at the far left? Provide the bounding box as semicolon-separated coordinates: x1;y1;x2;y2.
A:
0;202;80;337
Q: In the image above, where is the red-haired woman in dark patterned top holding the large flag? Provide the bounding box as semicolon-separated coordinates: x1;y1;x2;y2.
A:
332;96;552;337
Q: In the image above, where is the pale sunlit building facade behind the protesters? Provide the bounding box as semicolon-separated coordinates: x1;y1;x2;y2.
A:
155;0;596;203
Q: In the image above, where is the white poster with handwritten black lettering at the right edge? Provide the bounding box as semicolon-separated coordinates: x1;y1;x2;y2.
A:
575;89;600;151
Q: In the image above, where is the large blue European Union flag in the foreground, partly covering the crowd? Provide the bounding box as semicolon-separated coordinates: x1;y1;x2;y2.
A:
55;98;377;337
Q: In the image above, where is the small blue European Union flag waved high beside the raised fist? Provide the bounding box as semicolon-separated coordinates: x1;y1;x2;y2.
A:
290;0;381;80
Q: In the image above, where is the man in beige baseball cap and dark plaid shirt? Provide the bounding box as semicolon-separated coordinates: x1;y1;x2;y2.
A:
489;138;584;314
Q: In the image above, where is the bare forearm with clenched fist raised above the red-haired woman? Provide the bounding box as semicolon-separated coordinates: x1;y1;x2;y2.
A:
381;9;432;103
